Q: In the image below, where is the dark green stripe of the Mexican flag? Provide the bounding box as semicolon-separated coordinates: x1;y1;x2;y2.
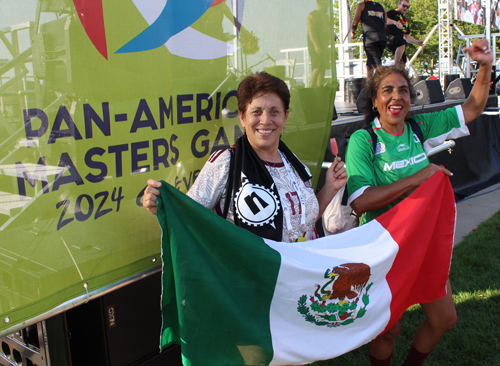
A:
157;182;281;365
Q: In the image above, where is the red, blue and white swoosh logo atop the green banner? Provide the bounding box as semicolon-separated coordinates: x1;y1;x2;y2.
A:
73;0;240;59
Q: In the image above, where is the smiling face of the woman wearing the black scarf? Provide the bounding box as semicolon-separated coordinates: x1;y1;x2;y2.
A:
239;92;288;162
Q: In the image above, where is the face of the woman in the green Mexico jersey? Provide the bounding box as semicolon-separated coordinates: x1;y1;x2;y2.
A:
373;73;411;133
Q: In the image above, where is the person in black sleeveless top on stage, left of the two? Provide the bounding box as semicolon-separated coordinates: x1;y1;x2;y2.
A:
351;0;387;78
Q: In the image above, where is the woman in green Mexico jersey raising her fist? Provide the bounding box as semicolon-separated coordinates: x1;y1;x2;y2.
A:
346;39;493;366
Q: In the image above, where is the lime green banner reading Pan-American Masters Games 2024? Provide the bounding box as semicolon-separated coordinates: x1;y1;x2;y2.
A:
0;0;337;335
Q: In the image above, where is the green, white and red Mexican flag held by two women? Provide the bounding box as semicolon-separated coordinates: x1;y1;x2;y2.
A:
157;172;455;365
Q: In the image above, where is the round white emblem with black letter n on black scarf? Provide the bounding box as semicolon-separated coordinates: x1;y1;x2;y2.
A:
234;174;280;227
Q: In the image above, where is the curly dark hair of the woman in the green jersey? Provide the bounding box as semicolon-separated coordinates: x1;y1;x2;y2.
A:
362;65;414;125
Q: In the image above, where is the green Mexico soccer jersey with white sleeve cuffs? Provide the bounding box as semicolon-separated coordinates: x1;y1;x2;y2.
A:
346;106;469;225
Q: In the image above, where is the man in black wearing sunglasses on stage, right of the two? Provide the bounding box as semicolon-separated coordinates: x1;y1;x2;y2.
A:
387;0;424;65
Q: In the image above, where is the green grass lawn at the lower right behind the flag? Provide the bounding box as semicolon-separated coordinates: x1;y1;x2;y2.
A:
313;211;500;366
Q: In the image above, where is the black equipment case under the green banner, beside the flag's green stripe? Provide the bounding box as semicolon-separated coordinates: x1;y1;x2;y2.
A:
66;273;182;366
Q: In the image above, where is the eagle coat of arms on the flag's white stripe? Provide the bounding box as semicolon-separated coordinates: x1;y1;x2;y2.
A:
297;263;373;327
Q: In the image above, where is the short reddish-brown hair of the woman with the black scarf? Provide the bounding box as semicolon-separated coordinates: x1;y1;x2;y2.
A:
236;71;290;114
